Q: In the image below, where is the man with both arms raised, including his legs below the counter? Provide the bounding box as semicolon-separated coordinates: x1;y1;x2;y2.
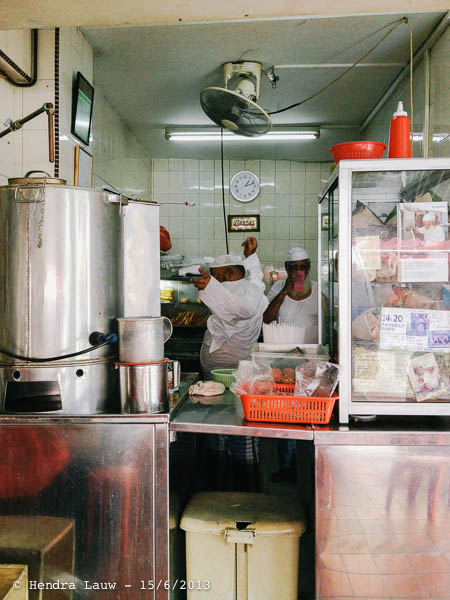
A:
192;238;268;491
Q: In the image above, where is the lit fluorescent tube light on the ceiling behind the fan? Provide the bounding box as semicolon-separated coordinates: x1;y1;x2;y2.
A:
165;125;320;142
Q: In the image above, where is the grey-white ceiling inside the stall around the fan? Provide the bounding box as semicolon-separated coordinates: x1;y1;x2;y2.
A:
83;13;444;160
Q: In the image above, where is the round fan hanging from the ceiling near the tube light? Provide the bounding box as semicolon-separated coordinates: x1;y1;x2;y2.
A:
200;61;272;137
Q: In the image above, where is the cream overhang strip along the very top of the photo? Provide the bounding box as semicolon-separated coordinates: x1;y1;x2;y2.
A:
0;0;448;29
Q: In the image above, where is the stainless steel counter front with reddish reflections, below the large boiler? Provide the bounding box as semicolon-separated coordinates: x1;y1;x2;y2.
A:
0;414;169;600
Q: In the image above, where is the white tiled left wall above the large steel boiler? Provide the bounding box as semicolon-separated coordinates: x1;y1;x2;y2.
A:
0;27;151;199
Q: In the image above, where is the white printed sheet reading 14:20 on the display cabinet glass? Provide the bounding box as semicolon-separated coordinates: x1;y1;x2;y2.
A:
380;307;450;352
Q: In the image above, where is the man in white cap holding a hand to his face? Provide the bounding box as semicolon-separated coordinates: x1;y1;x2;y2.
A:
264;248;318;344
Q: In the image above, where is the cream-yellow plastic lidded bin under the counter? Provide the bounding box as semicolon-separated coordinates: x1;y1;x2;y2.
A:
180;492;305;600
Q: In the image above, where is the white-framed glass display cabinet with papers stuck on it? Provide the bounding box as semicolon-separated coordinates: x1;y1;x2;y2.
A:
319;158;450;423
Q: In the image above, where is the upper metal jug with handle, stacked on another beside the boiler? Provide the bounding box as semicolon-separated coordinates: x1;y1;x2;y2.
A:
117;317;173;363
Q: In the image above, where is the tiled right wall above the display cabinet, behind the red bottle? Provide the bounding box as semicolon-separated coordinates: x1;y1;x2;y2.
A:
361;24;450;157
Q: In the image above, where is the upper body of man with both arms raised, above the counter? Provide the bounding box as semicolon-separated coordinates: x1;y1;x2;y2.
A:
192;238;268;375
